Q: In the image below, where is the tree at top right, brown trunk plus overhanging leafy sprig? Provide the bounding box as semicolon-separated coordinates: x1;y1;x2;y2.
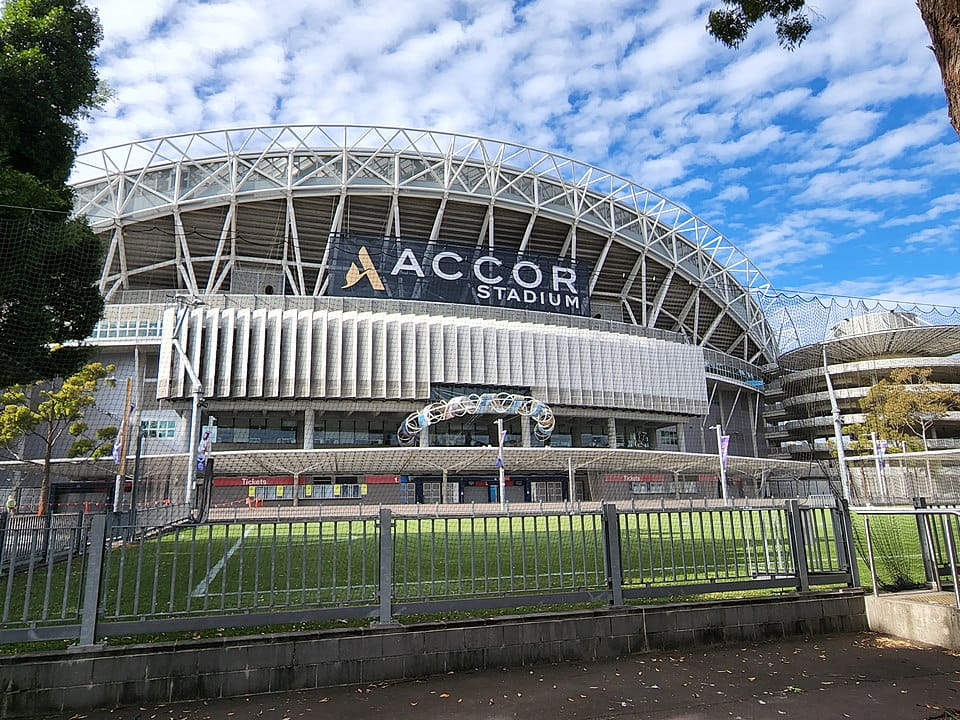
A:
707;0;960;135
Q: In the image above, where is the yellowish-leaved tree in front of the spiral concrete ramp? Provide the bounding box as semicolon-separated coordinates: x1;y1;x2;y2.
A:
860;367;960;450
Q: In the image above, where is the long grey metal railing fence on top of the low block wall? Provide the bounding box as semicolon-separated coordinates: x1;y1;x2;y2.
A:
0;501;859;645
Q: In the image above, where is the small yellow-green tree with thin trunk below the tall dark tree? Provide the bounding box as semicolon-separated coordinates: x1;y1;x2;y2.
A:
0;363;117;515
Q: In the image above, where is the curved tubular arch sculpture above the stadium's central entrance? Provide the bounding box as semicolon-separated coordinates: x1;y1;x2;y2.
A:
397;393;556;444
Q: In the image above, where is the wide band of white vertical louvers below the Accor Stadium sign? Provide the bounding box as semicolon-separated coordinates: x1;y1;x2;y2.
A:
157;308;707;414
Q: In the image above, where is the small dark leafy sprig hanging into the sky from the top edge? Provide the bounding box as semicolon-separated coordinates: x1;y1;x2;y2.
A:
707;0;813;50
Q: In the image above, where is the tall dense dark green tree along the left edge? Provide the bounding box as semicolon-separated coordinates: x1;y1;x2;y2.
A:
0;0;105;388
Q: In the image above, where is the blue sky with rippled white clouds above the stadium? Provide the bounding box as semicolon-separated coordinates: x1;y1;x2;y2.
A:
81;0;960;306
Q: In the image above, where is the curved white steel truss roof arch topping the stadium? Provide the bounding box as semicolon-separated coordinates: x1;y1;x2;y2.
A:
72;125;776;363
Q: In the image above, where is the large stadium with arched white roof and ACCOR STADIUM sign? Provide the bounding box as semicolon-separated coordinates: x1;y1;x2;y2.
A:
11;125;828;503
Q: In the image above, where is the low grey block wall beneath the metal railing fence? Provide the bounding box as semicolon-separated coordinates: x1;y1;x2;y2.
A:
0;591;867;718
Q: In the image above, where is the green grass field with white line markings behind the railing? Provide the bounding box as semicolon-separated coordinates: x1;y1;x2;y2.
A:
0;509;864;625
